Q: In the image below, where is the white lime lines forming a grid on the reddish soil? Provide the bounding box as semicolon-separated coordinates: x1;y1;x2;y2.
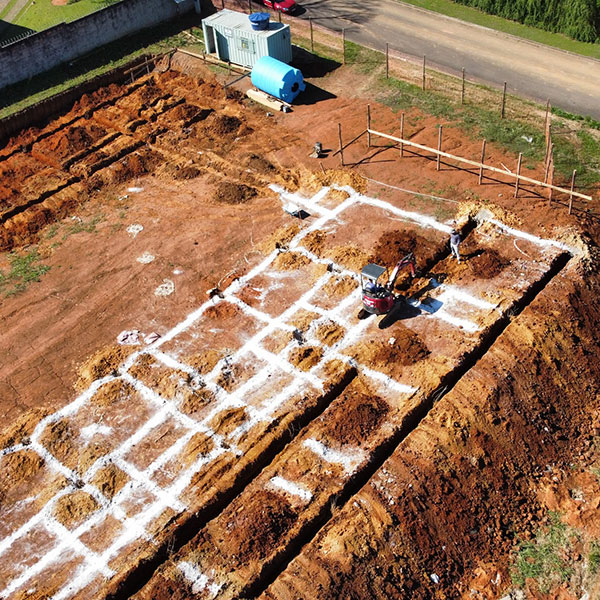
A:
0;186;545;600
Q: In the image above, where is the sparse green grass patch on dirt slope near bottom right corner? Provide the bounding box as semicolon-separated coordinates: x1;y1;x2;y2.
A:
511;512;576;594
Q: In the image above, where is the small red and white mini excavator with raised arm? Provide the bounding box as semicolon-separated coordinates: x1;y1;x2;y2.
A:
359;252;416;318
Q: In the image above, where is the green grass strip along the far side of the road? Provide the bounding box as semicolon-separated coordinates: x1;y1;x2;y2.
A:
403;0;600;58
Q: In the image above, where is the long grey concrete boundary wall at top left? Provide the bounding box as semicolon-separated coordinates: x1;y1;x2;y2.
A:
0;0;194;89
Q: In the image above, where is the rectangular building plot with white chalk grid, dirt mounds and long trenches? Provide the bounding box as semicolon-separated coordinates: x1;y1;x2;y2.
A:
0;183;568;600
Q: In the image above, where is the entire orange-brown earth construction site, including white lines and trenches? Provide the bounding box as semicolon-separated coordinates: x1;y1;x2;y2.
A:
0;48;600;600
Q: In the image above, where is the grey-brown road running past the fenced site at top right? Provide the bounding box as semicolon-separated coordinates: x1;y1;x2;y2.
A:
301;0;600;120
